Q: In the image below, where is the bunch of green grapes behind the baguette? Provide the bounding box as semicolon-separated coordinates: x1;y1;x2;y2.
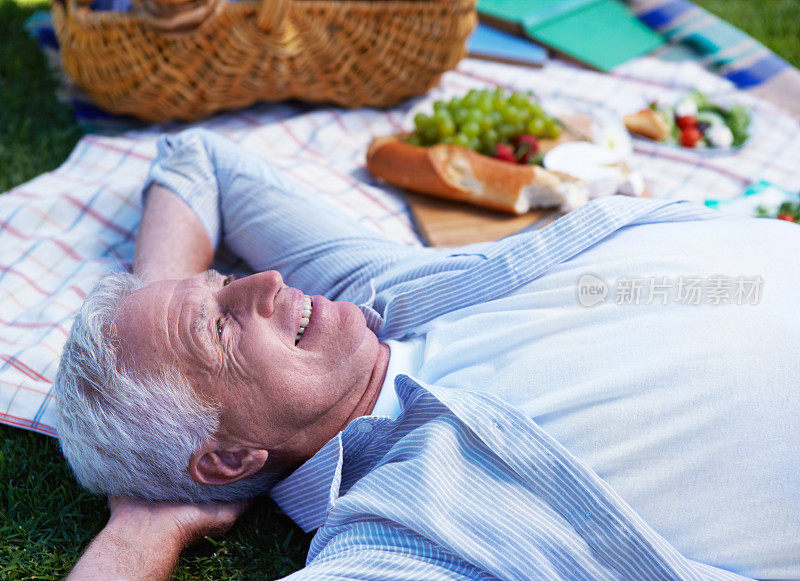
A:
407;88;561;155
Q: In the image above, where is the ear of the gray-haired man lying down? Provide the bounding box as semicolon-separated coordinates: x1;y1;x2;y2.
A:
189;438;269;485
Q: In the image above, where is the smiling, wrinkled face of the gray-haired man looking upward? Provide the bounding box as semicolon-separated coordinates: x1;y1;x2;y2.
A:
116;271;388;463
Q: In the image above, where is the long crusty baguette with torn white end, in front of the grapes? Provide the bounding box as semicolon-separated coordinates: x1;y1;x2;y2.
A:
367;136;588;214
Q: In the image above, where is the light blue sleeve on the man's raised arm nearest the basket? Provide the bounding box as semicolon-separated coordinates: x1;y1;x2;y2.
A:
144;129;432;299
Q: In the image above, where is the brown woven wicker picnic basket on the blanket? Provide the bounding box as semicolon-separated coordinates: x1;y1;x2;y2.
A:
52;0;477;122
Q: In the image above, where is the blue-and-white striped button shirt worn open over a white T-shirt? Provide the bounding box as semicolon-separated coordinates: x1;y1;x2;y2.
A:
149;130;752;580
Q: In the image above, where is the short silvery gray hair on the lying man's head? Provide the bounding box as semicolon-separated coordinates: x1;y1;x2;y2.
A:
55;272;277;502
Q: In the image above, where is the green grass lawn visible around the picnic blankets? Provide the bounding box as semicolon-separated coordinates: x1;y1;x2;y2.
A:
0;0;800;580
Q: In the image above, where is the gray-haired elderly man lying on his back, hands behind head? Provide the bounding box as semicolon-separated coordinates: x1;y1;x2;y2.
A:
56;130;800;579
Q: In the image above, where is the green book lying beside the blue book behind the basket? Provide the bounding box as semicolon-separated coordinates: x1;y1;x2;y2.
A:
478;0;664;71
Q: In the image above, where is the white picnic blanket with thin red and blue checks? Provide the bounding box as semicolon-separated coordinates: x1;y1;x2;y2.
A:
0;58;800;435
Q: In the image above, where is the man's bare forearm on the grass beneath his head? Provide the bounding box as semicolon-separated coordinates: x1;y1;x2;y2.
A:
68;499;246;581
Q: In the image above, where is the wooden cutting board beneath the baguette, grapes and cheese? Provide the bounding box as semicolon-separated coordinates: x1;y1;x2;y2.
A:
406;115;592;246
